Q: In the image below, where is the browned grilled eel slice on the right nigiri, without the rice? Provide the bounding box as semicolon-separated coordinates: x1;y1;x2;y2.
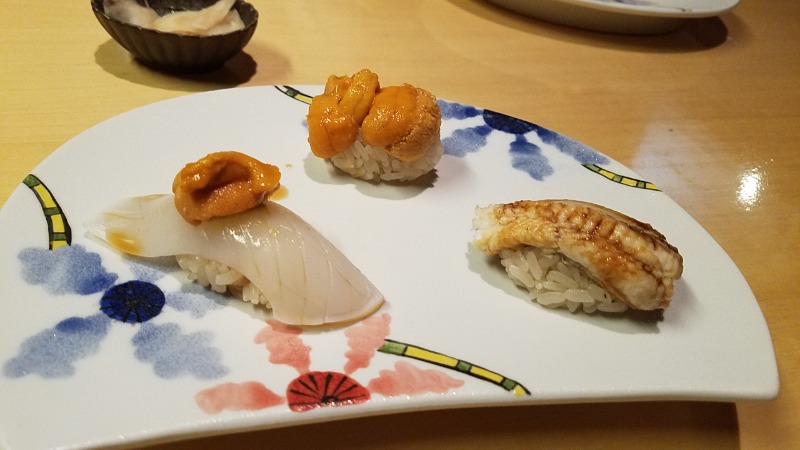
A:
473;200;683;310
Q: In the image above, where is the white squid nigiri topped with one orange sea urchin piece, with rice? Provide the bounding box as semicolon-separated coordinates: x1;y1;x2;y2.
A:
86;152;384;325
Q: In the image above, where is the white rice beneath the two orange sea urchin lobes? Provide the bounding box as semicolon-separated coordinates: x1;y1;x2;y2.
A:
330;136;444;181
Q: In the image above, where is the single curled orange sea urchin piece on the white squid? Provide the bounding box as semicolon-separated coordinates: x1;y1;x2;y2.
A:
172;152;281;224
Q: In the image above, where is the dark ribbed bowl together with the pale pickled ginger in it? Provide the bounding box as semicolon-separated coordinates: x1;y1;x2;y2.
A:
91;0;258;73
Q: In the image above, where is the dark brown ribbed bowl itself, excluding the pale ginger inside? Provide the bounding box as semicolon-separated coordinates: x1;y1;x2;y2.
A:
91;0;258;73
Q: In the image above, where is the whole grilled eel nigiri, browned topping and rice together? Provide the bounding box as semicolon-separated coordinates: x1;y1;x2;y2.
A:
473;200;683;313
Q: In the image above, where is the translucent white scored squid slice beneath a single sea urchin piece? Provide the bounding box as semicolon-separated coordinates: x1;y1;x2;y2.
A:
86;195;383;325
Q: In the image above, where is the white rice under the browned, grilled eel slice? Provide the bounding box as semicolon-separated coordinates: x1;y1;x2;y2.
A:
500;246;628;313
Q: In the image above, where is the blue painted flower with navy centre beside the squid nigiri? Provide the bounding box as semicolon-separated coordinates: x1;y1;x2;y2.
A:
3;245;228;379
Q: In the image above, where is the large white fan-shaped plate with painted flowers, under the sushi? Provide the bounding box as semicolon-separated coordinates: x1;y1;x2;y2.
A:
0;86;778;450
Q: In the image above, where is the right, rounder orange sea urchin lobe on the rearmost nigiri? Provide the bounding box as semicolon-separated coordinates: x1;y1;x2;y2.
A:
361;84;442;161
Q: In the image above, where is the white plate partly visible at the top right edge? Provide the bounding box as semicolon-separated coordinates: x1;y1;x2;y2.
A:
489;0;739;34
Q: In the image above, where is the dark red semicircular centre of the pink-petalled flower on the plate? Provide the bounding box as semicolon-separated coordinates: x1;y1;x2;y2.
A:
286;372;370;412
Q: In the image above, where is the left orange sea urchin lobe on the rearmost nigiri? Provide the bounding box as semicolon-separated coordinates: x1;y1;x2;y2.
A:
306;69;380;158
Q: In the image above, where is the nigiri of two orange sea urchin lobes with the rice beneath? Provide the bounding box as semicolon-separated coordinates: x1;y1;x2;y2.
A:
307;69;444;181
